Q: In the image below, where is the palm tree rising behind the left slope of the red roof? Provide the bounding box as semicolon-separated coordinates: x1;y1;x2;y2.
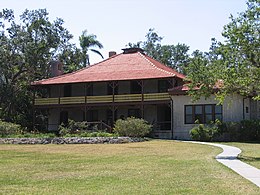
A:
79;30;104;66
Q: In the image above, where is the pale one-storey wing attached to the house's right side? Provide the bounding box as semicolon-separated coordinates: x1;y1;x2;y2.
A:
169;85;260;139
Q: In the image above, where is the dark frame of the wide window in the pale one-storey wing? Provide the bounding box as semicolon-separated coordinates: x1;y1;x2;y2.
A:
184;104;223;124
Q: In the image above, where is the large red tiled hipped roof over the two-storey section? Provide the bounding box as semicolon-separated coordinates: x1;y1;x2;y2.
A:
32;52;185;85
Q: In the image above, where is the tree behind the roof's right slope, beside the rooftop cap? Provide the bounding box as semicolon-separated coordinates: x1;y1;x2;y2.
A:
128;29;190;73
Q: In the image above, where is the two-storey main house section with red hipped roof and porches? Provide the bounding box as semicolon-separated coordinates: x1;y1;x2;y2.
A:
32;48;185;138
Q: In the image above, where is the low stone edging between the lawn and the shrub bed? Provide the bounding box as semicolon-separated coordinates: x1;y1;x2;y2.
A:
0;137;146;144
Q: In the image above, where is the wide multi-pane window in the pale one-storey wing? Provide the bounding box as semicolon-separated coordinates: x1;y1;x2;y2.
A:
184;104;222;124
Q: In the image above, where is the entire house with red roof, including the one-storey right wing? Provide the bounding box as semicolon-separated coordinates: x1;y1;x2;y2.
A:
32;48;259;139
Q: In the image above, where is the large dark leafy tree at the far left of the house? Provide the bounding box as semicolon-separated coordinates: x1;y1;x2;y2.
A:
0;9;83;127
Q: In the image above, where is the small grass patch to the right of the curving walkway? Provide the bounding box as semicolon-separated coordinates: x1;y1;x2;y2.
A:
225;142;260;169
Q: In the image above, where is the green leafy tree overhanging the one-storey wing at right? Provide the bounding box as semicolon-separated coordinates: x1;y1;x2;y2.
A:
186;0;260;102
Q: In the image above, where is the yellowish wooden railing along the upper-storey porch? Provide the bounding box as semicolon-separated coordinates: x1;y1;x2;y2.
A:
34;93;170;106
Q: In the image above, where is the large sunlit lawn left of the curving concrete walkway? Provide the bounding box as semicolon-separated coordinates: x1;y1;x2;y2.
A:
0;140;260;195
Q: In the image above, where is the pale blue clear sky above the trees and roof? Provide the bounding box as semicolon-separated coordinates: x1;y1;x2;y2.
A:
0;0;247;64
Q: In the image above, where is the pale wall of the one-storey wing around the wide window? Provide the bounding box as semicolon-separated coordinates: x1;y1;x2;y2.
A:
172;94;250;139
